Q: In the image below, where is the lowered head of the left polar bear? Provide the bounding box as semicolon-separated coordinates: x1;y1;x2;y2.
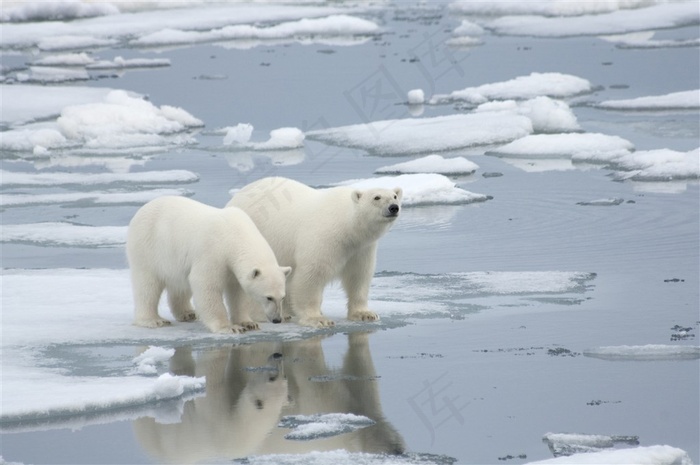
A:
241;266;292;323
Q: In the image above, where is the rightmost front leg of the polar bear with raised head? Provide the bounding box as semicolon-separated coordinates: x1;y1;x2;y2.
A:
341;243;379;321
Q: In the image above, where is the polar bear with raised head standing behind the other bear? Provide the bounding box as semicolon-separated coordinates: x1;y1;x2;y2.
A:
226;177;403;327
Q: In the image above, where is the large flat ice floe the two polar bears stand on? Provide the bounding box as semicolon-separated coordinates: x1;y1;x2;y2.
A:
0;266;593;422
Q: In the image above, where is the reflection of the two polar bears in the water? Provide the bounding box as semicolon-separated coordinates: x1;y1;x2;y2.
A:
133;333;405;463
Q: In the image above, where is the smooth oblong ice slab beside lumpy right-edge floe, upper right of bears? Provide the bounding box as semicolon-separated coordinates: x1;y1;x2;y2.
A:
490;133;634;158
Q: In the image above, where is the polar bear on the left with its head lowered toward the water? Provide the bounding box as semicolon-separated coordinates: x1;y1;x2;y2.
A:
126;196;291;333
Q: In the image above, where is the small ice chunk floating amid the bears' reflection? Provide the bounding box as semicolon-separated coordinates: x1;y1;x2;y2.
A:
278;413;376;441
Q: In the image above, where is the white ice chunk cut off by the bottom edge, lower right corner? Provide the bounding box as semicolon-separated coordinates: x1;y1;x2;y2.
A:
527;446;693;465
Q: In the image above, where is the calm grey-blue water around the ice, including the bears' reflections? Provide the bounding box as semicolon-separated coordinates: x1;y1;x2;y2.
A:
0;5;700;464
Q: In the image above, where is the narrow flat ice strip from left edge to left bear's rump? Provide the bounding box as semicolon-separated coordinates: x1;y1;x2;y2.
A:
0;222;127;247
